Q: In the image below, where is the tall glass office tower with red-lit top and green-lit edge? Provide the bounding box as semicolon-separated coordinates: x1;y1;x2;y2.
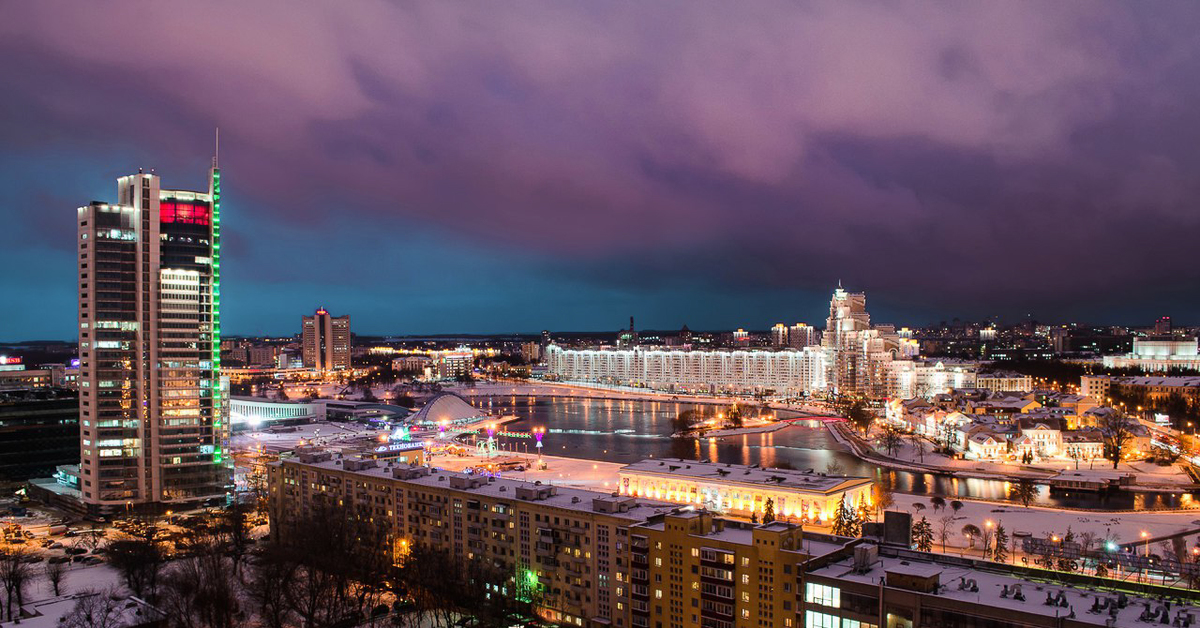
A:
78;157;233;514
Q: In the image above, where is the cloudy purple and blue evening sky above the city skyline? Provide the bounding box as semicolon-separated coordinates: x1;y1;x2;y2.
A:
0;0;1200;340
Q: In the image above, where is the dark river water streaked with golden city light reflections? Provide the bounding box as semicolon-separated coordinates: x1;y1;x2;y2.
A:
474;396;1192;510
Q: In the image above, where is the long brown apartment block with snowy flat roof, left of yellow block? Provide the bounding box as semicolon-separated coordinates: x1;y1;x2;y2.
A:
268;453;677;627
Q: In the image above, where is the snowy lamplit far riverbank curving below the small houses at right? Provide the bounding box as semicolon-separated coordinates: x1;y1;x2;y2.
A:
827;421;1200;494
